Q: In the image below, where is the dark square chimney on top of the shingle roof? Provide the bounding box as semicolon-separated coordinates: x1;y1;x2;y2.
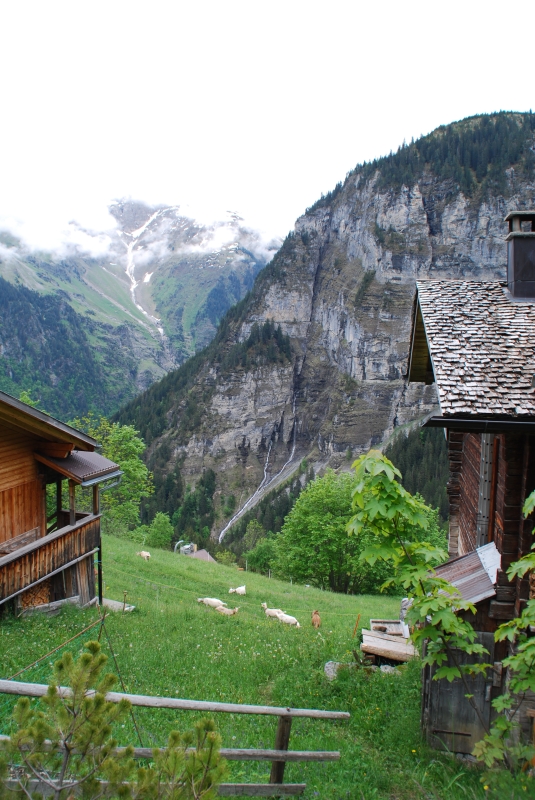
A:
505;211;535;300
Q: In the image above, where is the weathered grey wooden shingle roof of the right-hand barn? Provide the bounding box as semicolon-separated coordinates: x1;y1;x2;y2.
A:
409;280;535;419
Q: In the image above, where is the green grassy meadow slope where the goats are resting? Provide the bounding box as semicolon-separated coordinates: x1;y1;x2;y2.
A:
0;538;486;800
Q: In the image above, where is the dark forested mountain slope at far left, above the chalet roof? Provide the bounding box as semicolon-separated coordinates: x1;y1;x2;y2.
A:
0;277;142;419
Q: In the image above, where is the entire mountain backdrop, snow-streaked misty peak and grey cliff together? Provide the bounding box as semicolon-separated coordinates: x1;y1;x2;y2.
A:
0;112;535;543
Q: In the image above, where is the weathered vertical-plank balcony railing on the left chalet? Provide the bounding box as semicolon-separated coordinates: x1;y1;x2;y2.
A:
0;516;100;602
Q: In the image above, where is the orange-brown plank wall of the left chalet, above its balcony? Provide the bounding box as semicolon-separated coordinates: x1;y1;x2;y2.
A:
0;424;46;542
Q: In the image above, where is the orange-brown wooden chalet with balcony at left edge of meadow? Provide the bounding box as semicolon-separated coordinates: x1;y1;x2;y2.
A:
0;392;122;612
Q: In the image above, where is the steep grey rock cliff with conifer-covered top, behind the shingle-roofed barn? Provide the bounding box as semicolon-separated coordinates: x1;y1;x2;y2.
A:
116;114;535;533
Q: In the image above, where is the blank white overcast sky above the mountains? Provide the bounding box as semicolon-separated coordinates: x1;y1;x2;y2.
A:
0;0;535;252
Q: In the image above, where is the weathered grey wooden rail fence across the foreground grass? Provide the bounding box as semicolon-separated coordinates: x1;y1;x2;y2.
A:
0;680;350;797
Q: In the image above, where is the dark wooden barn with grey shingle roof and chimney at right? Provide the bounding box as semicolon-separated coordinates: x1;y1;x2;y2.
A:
409;211;535;753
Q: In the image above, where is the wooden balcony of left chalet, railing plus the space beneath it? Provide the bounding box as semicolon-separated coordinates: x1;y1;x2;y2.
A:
0;512;100;608
